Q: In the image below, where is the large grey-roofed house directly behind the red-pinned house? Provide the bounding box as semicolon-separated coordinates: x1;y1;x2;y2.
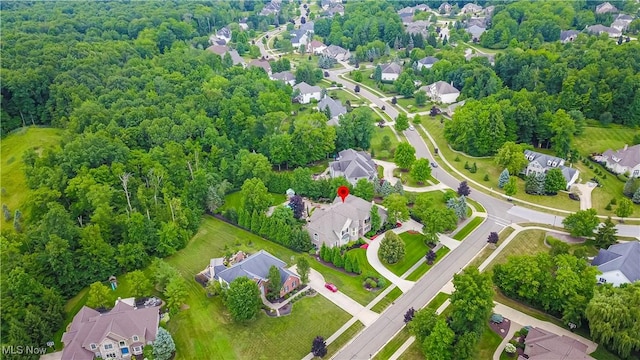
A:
329;149;378;185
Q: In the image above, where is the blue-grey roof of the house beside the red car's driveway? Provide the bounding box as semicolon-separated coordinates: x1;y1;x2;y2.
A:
215;250;298;284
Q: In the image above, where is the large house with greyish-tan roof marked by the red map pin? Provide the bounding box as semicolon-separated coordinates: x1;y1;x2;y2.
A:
307;195;387;248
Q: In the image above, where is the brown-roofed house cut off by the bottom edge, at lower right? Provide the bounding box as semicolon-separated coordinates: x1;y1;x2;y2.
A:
518;327;593;360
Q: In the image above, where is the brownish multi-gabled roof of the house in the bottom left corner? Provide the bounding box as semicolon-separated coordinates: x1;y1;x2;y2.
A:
62;300;160;360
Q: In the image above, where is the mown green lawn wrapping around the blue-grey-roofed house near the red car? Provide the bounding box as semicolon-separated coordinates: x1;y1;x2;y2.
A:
162;217;350;359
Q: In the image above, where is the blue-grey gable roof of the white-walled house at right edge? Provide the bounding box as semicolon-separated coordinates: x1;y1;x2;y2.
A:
591;241;640;282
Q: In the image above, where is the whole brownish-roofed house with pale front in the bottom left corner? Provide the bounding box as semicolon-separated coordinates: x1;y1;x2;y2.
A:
62;298;160;360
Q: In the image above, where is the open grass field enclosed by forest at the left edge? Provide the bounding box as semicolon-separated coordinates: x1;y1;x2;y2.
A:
0;127;62;218
